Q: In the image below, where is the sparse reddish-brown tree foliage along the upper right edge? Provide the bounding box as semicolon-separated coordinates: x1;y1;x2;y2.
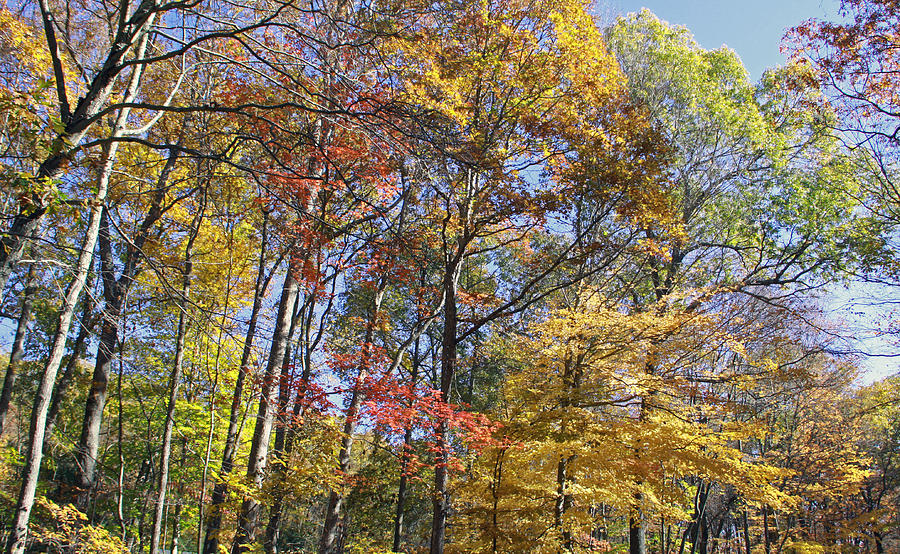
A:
782;0;900;340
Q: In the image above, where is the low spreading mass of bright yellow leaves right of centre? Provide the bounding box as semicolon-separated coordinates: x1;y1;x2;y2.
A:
454;291;796;551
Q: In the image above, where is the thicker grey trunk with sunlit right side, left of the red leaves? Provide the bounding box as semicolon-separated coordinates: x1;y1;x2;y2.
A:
231;264;298;554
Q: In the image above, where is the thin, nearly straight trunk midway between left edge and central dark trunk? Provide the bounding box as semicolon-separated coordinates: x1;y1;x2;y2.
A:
150;196;203;554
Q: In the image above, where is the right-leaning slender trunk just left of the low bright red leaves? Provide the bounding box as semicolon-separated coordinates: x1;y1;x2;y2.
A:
319;281;384;554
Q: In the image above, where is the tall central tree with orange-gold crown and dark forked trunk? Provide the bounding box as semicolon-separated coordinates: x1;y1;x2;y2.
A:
388;2;676;552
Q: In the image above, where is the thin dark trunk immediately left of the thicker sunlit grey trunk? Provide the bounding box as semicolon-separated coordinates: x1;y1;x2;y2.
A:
203;212;269;554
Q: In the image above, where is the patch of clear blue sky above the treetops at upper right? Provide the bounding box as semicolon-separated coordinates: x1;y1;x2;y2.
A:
601;0;839;80
